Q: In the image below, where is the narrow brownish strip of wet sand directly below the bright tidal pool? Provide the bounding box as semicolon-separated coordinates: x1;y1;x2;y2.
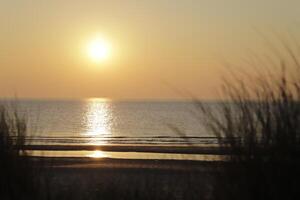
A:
26;157;224;172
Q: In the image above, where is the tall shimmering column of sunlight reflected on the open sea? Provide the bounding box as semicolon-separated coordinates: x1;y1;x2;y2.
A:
83;98;111;145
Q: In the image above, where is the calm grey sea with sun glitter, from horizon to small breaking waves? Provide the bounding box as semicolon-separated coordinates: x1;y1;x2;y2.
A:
0;99;216;145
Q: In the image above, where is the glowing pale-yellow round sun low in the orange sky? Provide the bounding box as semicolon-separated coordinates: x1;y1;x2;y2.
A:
87;38;111;62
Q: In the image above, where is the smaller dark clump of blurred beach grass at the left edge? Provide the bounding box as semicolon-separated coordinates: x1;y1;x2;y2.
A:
0;106;39;199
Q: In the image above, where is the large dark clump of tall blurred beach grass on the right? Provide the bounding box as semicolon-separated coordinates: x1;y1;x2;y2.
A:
198;39;300;199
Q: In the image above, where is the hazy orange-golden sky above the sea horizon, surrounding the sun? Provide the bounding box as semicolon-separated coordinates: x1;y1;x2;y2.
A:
0;0;300;99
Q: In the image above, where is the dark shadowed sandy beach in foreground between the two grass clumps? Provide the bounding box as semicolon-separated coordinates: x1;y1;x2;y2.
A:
32;157;219;199
